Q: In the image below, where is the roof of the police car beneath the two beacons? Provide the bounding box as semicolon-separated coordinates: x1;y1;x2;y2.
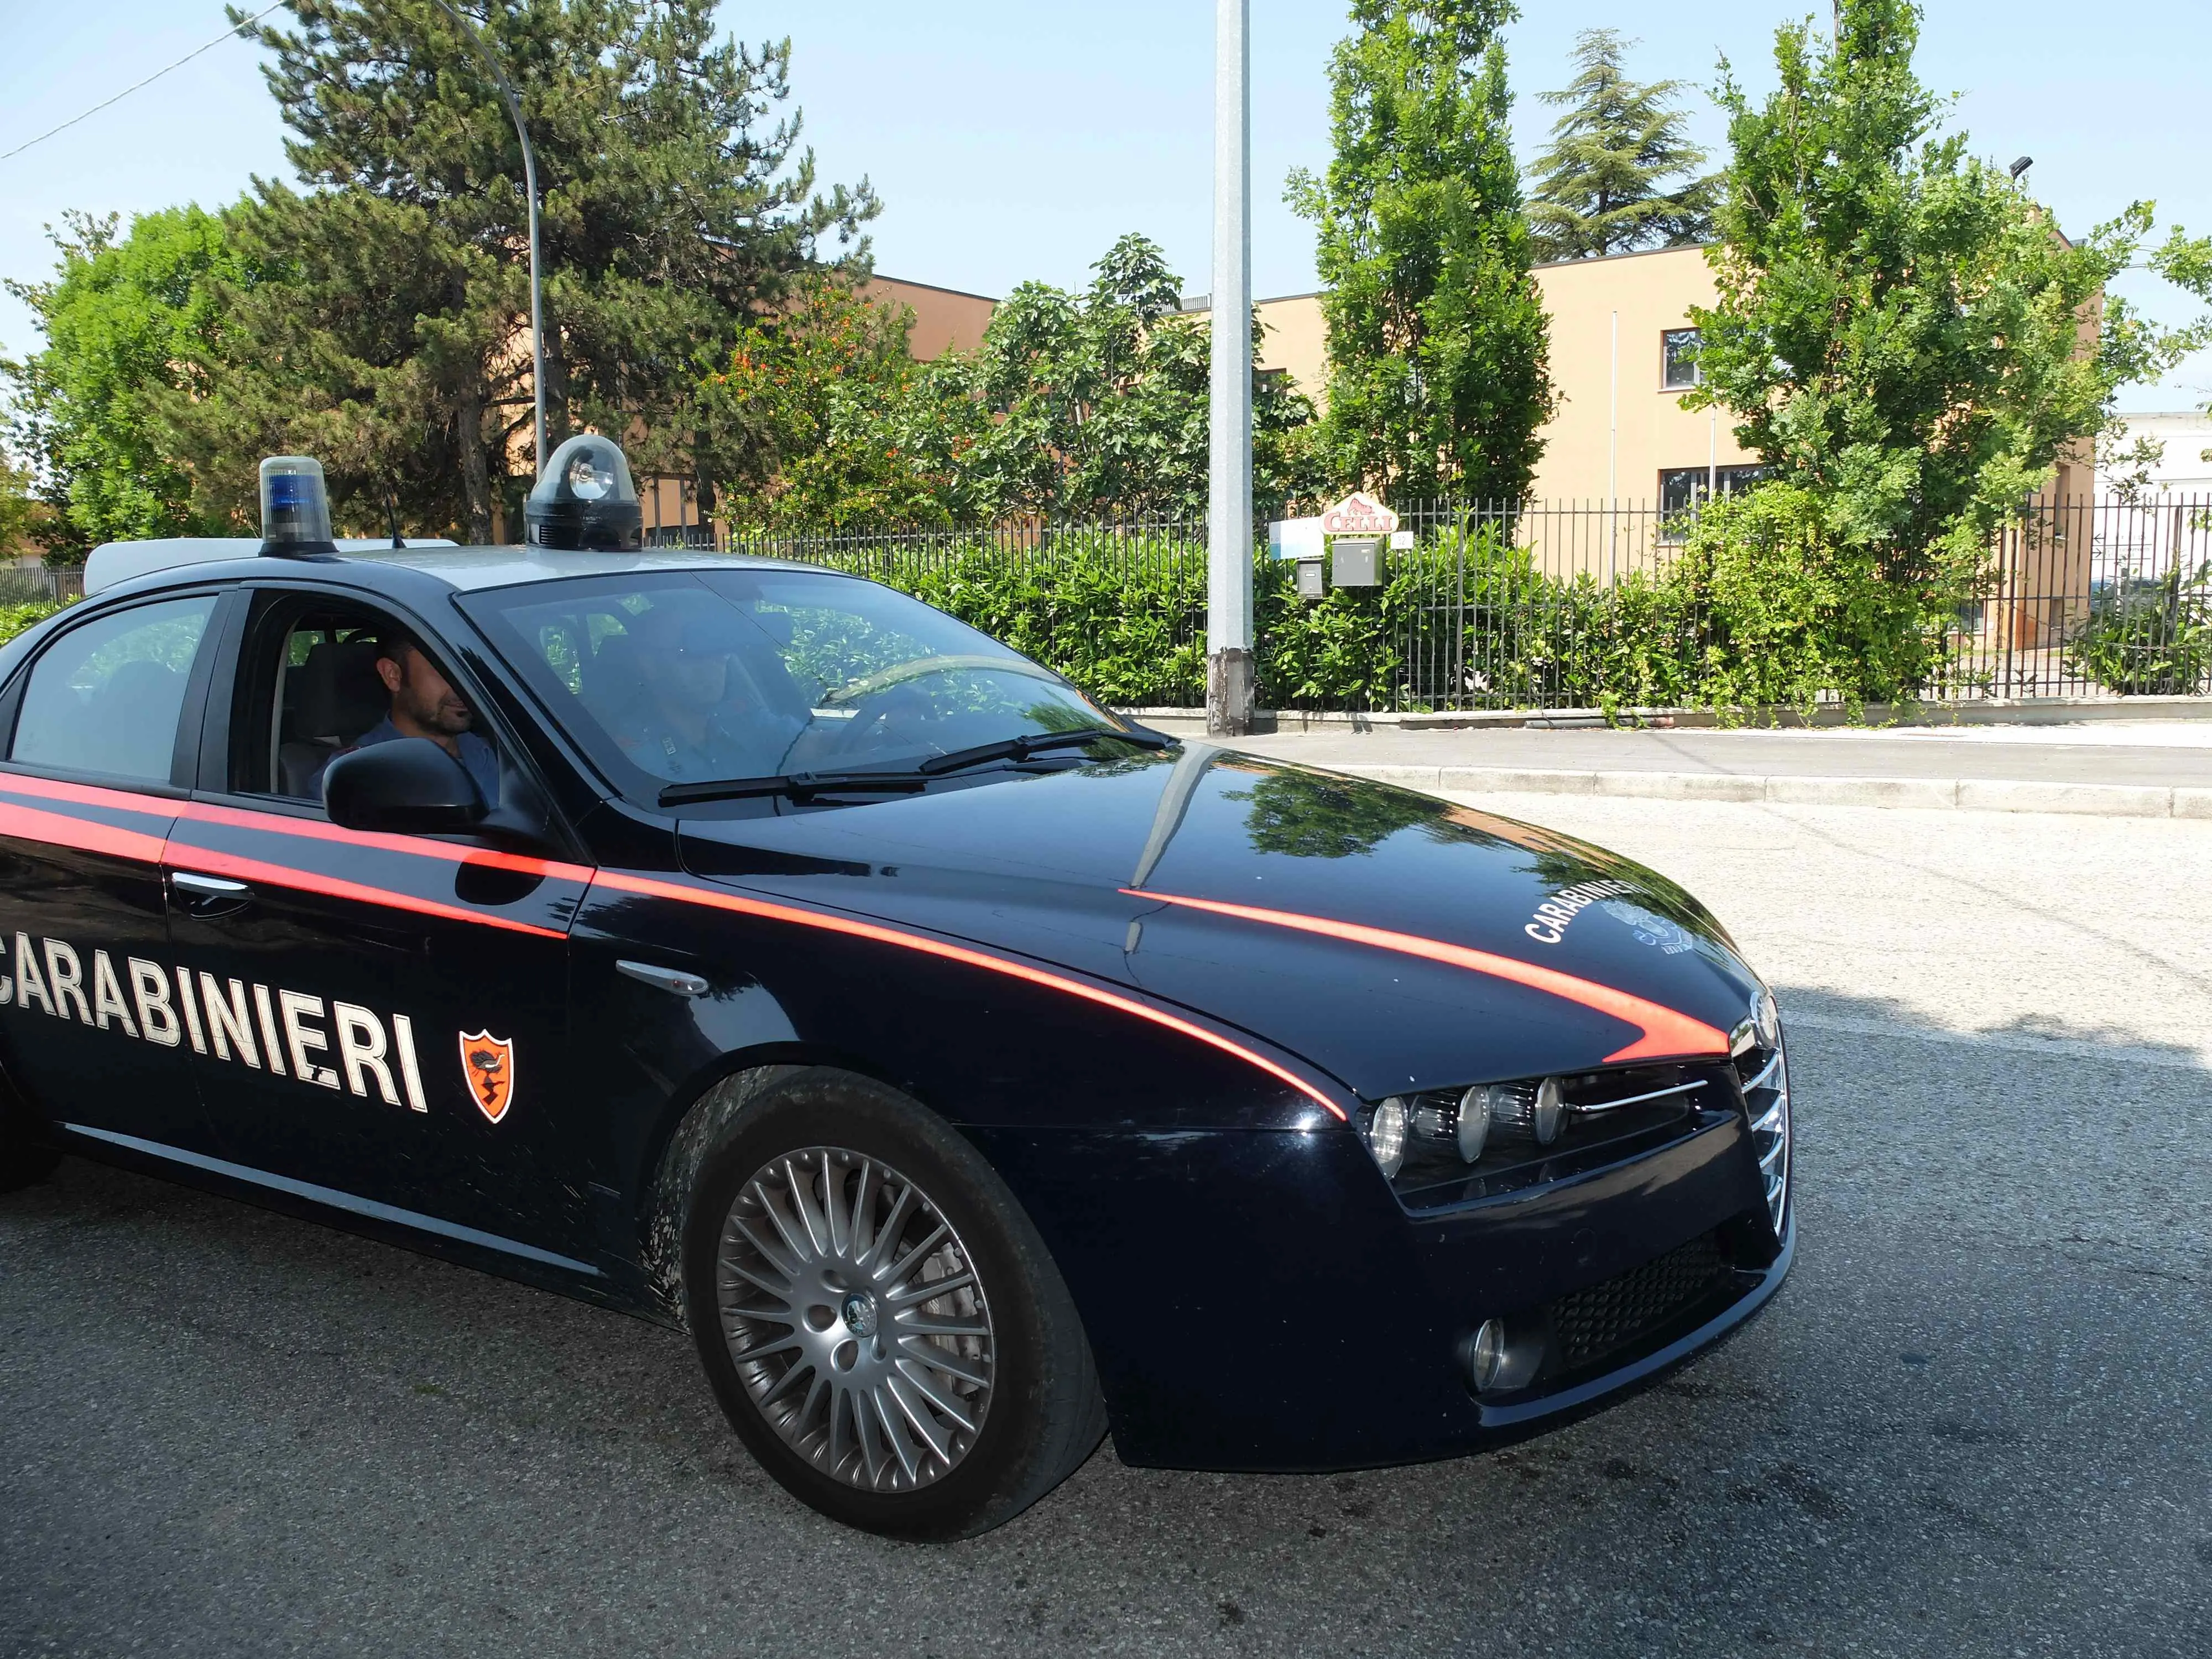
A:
84;535;818;595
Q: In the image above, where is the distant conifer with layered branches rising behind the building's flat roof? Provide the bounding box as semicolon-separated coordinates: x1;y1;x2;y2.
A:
1528;29;1717;259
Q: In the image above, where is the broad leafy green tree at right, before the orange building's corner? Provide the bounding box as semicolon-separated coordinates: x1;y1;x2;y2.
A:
1688;0;2194;582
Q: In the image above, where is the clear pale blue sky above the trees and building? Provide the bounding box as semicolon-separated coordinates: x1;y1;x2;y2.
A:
0;0;2212;409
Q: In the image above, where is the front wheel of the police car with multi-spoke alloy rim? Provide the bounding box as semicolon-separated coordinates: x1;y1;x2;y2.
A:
684;1066;1106;1540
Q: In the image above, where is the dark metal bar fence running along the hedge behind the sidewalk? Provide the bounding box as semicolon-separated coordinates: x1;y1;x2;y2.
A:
717;498;2212;712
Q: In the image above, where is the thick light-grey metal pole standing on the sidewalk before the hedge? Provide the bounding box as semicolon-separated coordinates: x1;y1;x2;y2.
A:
1206;0;1252;737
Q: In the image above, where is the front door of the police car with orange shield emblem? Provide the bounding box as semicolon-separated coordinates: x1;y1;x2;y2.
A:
168;588;593;1267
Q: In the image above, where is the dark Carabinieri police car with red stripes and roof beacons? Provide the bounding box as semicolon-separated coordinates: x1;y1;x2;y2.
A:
0;438;1794;1537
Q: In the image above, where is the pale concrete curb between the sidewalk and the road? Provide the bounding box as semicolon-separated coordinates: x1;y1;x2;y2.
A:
1329;765;2212;821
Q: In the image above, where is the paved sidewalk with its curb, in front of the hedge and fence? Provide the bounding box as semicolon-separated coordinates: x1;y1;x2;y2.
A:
1234;721;2212;818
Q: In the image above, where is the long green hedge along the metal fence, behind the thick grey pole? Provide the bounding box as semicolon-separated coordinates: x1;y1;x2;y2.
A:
796;487;1944;710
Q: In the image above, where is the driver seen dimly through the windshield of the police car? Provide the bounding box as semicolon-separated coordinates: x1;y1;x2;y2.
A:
613;604;805;783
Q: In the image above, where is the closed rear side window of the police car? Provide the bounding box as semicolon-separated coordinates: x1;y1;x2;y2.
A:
9;595;215;783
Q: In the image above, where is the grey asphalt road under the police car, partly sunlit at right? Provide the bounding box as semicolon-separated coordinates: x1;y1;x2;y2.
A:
0;796;2212;1659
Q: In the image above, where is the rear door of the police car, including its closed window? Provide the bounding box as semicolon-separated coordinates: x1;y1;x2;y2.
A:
0;591;226;1155
